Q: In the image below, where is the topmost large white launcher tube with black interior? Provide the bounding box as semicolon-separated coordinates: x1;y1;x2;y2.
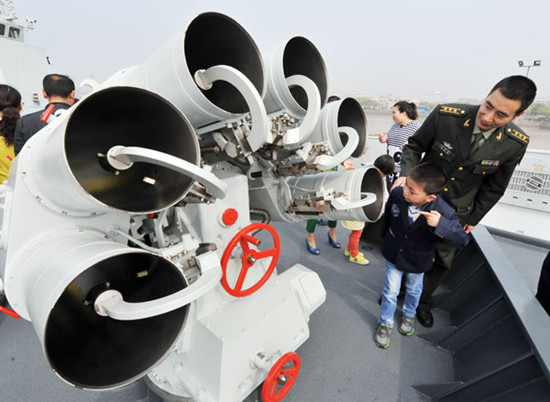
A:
105;12;265;128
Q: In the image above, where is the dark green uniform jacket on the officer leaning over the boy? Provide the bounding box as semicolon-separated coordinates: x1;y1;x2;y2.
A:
401;104;529;225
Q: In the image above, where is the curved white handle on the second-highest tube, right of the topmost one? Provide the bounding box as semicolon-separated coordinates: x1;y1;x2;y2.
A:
285;75;321;144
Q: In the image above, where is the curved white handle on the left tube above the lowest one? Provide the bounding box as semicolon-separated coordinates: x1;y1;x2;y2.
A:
107;145;227;199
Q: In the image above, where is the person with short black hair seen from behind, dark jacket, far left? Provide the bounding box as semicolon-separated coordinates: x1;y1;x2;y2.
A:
13;74;75;155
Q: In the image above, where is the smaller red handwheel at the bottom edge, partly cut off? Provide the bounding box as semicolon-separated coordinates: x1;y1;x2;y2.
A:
262;352;300;402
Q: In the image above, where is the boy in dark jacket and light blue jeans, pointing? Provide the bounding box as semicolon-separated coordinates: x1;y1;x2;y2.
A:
374;163;470;349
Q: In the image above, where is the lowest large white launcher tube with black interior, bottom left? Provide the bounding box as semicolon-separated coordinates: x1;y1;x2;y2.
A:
10;230;188;389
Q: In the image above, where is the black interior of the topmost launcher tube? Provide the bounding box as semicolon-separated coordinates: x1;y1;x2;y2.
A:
184;13;265;113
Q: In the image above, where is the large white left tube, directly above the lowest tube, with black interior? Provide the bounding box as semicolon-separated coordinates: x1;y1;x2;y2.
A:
17;87;205;216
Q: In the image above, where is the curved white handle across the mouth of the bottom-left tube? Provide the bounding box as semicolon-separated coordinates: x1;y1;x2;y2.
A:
94;251;222;321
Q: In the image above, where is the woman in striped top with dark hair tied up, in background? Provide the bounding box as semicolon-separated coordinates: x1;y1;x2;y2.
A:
378;101;420;190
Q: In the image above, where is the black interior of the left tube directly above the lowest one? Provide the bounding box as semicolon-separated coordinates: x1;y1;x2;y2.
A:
65;87;199;212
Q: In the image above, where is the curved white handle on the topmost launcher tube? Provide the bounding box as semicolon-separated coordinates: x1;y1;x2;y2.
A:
195;65;269;152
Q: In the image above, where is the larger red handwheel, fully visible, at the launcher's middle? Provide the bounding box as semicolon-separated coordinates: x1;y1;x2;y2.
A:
221;223;281;297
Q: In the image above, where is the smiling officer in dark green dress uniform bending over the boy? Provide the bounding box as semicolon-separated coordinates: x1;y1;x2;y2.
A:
395;76;536;327
